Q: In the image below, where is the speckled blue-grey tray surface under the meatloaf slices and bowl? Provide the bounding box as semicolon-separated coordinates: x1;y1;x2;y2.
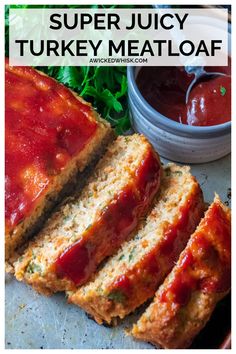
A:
5;155;231;349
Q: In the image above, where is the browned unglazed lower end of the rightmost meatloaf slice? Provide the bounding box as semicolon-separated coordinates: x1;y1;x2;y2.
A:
132;291;228;349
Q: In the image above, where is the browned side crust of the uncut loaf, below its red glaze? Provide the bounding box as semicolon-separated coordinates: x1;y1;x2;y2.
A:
5;65;115;260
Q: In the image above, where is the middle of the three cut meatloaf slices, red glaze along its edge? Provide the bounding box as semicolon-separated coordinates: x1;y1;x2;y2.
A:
68;164;204;323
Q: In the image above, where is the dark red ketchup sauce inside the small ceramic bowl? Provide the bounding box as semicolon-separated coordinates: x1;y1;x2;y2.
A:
136;59;231;126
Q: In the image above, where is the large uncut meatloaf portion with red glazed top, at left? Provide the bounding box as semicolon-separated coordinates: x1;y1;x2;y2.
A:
5;60;113;259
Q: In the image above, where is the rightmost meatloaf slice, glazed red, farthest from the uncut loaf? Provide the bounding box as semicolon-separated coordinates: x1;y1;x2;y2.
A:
132;196;231;348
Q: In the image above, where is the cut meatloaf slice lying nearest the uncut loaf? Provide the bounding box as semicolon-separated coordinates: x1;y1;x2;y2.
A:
15;134;162;293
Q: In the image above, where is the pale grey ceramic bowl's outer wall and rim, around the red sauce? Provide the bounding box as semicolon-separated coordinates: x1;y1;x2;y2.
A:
127;18;231;163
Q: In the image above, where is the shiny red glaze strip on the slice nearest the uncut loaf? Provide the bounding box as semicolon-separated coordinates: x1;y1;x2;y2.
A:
55;149;161;286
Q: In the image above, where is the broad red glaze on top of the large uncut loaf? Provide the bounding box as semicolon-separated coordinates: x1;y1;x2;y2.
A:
5;61;97;230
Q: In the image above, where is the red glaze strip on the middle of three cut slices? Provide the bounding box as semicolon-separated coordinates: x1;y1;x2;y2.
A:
107;188;203;307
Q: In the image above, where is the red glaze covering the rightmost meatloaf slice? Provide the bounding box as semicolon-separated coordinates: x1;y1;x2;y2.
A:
160;203;231;306
